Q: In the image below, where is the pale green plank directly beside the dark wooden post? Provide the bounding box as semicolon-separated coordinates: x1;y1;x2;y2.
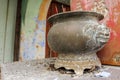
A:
4;0;19;62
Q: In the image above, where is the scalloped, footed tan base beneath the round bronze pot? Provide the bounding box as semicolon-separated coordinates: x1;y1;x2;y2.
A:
55;53;101;75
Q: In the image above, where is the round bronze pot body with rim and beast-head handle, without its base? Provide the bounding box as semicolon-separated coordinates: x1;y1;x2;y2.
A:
48;11;110;53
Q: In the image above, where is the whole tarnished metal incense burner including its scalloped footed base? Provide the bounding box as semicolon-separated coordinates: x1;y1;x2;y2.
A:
48;11;110;75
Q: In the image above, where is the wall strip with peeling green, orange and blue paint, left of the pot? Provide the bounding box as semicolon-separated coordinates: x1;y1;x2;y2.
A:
19;0;51;60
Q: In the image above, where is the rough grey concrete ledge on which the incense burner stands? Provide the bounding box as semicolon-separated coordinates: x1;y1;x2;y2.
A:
1;59;120;80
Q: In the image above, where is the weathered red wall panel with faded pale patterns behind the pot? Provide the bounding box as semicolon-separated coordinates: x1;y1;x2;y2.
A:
71;0;120;65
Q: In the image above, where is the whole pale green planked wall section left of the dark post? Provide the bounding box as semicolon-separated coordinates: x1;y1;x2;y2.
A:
0;0;17;63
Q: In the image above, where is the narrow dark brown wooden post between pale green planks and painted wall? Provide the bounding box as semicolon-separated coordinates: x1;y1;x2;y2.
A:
14;0;22;61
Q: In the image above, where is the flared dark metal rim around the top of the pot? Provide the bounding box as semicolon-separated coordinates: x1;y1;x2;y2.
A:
48;11;104;23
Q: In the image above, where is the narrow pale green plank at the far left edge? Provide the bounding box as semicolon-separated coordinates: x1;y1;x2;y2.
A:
0;0;8;63
